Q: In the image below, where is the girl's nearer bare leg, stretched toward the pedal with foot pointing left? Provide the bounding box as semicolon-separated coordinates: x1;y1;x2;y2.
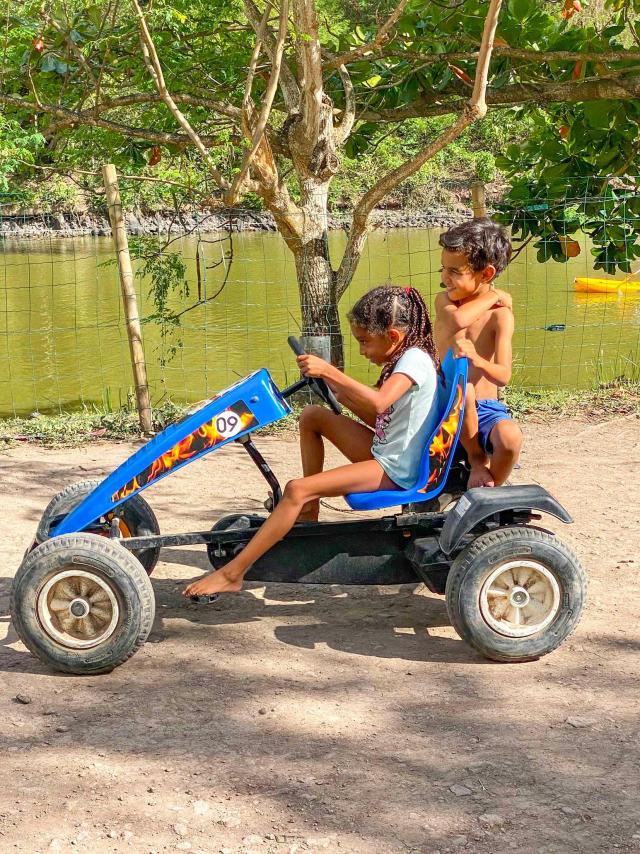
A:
184;460;398;596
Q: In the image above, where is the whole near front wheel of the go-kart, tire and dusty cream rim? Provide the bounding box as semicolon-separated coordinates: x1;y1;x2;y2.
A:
11;533;155;675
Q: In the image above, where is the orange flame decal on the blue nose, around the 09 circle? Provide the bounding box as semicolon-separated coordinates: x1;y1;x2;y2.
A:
111;401;258;501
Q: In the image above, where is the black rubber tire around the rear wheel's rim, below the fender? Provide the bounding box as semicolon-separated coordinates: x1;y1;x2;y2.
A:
445;525;587;662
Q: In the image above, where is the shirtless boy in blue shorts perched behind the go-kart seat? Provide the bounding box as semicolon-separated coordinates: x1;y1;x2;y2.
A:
435;219;522;487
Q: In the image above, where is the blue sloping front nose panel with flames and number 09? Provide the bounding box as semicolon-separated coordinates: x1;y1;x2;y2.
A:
52;368;291;536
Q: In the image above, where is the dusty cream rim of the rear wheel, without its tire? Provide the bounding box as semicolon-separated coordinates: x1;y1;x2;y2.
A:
479;559;561;638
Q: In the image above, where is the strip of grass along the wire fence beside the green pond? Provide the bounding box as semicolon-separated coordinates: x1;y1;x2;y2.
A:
0;380;640;448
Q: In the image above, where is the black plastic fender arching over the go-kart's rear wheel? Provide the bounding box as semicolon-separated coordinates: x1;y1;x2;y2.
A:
440;484;573;555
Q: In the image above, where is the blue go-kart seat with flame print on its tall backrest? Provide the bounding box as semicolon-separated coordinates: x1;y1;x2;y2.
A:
345;350;468;510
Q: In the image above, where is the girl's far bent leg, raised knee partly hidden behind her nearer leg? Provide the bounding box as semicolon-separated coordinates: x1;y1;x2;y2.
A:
299;406;373;522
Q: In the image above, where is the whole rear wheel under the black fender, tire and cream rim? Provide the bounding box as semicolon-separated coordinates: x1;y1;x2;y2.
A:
446;526;587;661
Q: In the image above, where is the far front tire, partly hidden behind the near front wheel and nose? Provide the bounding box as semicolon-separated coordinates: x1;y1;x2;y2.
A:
36;480;160;575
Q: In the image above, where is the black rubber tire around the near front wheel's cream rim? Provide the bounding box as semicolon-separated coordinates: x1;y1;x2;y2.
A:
11;533;155;675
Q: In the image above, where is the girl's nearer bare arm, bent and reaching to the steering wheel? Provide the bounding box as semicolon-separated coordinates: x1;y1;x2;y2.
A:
298;353;413;418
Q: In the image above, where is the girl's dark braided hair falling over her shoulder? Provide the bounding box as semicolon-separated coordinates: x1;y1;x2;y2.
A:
347;285;440;388
